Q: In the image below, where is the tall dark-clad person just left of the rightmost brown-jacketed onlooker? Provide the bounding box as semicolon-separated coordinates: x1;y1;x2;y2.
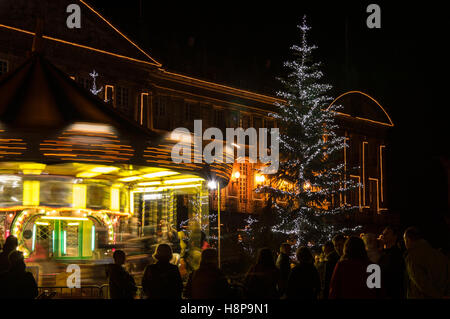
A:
378;226;405;299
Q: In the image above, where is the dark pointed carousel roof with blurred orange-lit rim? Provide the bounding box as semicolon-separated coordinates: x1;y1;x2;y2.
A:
0;53;232;186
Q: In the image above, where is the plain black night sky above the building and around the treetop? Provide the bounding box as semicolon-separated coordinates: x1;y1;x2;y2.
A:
89;0;449;242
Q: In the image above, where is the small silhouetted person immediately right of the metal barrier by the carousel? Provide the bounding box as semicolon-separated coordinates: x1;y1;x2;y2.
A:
107;250;137;299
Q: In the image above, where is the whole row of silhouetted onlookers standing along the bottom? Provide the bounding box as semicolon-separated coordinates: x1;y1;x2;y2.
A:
0;226;450;300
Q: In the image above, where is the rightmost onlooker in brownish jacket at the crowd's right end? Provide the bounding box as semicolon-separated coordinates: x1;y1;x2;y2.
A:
403;227;450;299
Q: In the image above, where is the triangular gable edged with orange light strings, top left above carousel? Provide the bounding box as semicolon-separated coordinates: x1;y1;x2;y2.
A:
0;0;161;67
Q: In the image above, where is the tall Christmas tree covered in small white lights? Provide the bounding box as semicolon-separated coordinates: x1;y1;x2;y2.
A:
247;17;358;252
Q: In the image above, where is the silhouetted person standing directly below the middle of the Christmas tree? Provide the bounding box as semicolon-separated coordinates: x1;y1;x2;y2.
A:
287;247;320;300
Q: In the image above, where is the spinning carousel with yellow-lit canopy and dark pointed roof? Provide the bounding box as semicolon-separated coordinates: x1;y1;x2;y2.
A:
0;54;232;260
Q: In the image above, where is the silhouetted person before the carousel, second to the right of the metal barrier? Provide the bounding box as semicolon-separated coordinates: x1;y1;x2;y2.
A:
142;244;183;299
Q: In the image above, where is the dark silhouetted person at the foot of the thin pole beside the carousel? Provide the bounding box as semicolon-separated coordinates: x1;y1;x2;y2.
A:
184;248;231;299
